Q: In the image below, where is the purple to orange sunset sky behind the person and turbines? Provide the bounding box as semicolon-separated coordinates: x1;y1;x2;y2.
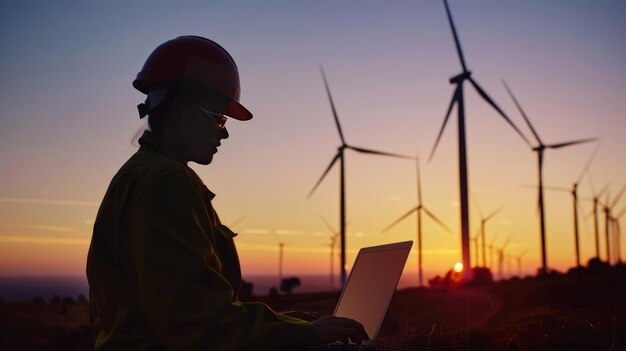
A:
0;0;626;286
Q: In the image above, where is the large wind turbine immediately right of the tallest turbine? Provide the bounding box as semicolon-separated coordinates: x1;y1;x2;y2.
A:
502;80;597;275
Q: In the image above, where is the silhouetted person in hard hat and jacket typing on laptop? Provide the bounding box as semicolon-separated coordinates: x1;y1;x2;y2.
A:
87;36;367;350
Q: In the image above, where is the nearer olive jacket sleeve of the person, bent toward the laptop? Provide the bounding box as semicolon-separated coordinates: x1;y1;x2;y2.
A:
128;173;314;350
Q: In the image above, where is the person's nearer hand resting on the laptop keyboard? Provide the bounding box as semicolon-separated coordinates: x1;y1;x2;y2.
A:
311;316;369;345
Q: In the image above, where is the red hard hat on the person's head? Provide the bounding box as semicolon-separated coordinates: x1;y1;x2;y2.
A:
133;36;252;121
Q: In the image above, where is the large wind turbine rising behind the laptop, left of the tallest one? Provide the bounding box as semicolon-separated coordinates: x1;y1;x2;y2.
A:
307;66;412;288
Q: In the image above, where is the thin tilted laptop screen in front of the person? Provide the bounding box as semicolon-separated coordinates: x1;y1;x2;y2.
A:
334;241;413;339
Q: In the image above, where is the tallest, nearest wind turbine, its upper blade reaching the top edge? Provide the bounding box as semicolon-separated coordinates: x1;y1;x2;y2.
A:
429;0;530;281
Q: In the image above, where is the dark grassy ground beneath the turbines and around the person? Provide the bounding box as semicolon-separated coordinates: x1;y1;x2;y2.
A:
0;265;626;350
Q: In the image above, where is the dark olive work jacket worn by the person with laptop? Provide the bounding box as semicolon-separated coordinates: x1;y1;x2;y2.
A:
87;131;314;350
